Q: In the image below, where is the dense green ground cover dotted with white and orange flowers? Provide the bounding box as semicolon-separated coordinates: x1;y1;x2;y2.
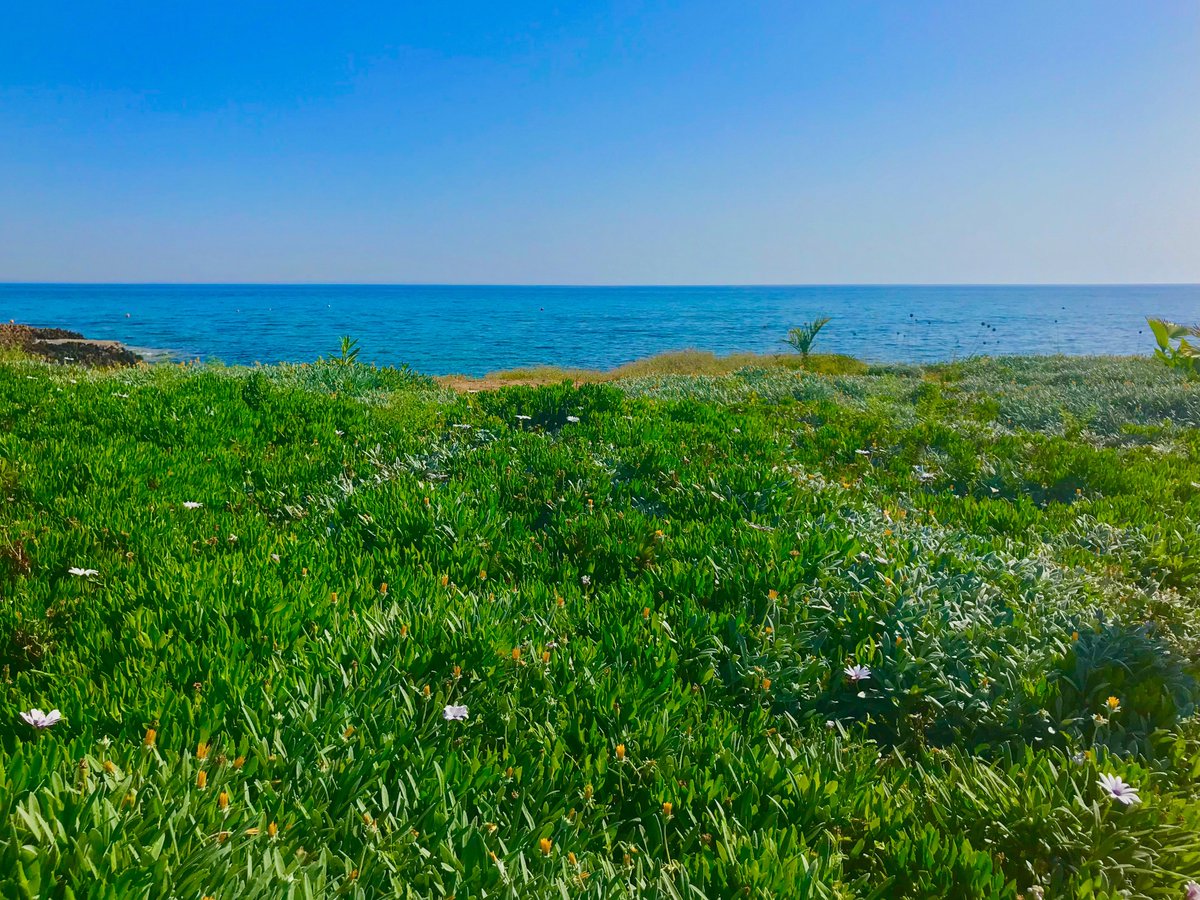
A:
0;359;1200;898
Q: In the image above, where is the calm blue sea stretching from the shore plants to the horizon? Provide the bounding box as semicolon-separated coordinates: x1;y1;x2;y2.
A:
0;284;1200;374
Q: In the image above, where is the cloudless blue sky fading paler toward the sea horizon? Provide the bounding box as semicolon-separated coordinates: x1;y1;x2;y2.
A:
0;0;1200;283
